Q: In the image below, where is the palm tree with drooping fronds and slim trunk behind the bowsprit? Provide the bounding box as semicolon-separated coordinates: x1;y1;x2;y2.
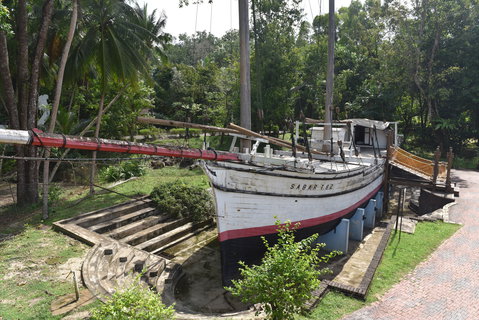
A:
65;0;168;193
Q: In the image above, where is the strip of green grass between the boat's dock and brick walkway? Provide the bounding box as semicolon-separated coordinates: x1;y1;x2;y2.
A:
299;222;461;320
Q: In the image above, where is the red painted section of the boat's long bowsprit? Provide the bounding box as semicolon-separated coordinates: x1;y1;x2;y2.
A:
31;129;239;161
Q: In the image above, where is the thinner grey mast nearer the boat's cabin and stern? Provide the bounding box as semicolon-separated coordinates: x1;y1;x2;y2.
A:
323;0;336;152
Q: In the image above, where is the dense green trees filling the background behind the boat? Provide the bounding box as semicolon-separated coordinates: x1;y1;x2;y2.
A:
0;0;479;203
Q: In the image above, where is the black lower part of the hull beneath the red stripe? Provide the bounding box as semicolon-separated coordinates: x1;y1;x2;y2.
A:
220;191;376;286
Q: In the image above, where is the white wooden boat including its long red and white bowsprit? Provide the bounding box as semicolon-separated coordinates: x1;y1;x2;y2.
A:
0;117;385;284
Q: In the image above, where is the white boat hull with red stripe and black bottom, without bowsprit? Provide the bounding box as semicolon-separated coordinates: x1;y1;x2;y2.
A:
204;162;383;284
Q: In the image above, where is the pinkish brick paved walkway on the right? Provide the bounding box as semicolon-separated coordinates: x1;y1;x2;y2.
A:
344;171;479;320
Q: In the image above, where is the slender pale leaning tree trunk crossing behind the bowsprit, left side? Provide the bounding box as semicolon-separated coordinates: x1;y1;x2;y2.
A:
42;0;78;219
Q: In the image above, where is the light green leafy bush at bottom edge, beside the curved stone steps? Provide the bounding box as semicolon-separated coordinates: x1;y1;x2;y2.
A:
91;279;175;320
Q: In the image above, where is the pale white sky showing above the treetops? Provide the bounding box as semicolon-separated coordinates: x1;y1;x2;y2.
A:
148;0;351;37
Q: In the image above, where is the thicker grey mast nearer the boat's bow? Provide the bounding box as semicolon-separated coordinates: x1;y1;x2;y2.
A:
238;0;251;152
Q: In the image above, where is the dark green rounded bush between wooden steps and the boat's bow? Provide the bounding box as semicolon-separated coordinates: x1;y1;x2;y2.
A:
151;182;214;221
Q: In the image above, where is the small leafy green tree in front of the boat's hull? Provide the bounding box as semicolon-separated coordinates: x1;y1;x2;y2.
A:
226;220;340;320
